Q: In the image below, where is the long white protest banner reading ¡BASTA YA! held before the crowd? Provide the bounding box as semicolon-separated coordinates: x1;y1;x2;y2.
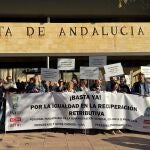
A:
6;92;150;132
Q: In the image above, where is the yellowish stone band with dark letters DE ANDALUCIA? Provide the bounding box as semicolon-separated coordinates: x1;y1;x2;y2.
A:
0;23;150;54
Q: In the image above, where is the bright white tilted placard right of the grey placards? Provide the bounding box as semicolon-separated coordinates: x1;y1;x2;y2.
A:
104;63;124;77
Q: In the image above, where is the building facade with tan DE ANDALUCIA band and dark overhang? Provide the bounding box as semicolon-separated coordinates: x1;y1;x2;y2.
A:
0;0;150;80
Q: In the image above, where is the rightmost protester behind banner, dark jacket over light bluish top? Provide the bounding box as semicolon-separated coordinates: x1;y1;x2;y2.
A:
131;72;149;96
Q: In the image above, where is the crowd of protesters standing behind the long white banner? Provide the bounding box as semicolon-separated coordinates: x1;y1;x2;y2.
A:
0;73;150;134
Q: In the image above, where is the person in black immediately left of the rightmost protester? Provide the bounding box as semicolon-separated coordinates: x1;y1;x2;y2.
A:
119;75;131;94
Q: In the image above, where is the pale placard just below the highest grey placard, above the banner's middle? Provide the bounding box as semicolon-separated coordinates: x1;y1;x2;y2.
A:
80;67;100;80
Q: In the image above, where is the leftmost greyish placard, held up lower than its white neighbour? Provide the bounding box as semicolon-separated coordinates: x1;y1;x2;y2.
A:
41;68;59;82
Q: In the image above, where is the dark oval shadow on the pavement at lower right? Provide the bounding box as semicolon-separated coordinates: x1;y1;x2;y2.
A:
103;134;150;150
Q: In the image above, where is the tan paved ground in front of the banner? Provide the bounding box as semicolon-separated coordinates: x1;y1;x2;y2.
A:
0;131;150;150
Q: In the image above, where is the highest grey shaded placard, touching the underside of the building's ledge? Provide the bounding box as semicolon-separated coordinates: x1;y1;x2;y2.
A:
89;56;107;68
